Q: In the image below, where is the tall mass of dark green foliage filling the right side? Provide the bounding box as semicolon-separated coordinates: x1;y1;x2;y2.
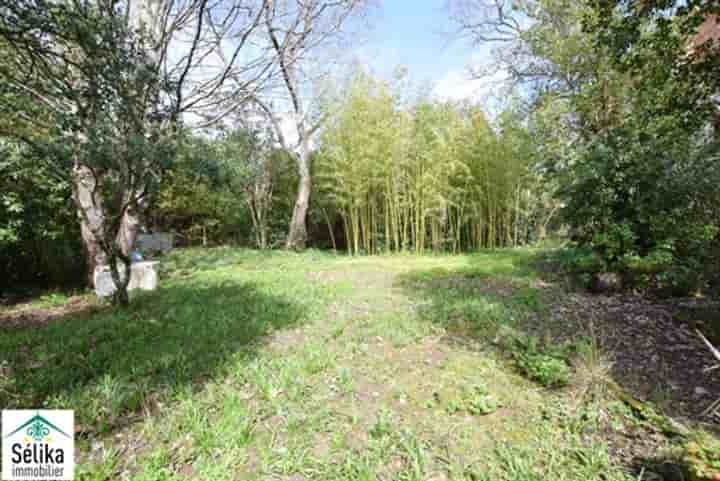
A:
490;0;720;295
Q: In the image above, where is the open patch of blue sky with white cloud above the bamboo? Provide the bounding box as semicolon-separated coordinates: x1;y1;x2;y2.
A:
355;0;498;102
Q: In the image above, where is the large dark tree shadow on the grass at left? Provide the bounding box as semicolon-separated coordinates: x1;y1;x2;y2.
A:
0;279;305;432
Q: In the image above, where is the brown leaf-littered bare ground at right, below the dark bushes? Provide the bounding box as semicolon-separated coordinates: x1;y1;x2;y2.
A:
537;292;720;431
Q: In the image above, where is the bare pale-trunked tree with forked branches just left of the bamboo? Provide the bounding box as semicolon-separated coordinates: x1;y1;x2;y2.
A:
257;0;367;249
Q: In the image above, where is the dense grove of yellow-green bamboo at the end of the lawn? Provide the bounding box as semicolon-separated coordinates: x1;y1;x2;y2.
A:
315;73;538;254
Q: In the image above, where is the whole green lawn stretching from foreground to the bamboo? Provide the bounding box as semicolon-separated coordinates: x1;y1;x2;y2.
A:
0;248;712;481
